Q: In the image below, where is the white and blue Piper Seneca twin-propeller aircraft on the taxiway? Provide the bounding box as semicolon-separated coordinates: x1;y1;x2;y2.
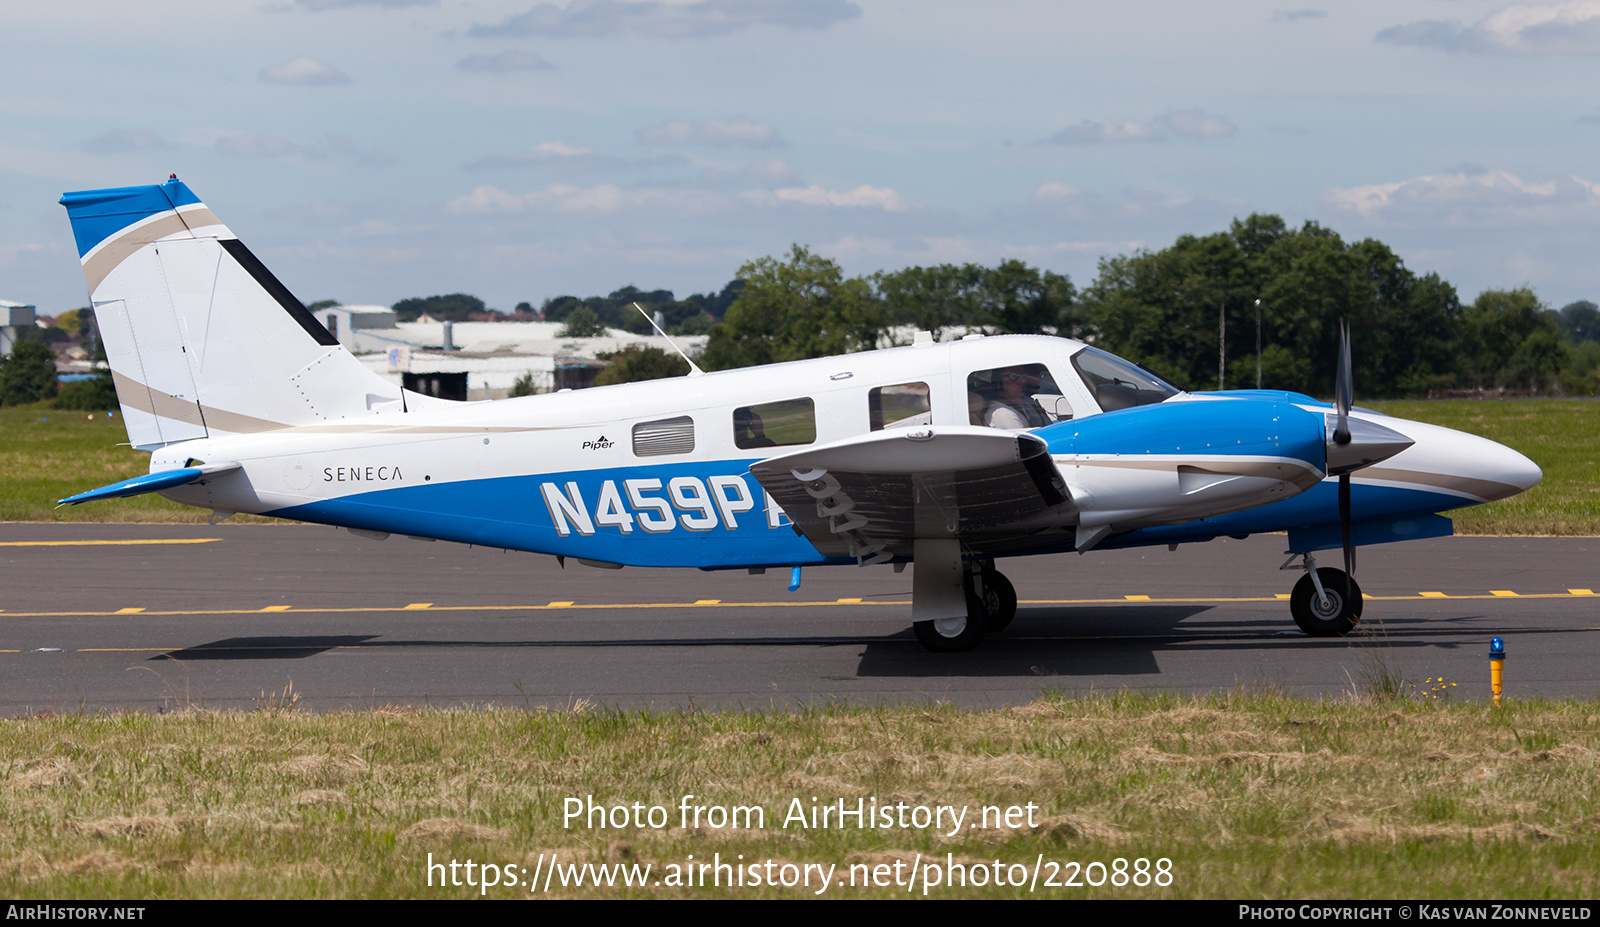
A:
61;176;1542;652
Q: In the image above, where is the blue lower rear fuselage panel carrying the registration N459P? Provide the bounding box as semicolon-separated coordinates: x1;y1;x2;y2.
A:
266;461;853;567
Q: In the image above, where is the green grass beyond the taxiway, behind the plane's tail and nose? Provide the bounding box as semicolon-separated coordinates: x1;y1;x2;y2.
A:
0;400;1600;535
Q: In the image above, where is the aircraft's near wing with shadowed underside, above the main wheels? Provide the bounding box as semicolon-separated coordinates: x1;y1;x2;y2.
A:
750;426;1072;564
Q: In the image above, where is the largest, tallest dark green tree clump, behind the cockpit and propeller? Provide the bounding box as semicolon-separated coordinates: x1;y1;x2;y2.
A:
1080;215;1461;397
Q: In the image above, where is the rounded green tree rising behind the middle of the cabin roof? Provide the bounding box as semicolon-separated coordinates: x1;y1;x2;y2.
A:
702;245;885;370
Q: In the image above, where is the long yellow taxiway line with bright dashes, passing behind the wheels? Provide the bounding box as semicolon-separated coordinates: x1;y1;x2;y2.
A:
5;592;1594;618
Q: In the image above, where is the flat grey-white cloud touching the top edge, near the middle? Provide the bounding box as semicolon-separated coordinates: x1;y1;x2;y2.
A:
467;0;861;38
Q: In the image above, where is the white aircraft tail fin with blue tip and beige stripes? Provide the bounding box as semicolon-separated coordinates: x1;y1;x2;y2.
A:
61;176;405;448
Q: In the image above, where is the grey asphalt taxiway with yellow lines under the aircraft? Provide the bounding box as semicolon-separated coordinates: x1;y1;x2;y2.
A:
0;524;1600;716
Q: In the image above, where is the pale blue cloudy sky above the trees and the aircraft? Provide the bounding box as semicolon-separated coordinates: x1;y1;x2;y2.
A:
0;0;1600;312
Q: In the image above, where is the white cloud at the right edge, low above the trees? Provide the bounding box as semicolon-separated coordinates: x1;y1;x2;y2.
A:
1322;170;1600;227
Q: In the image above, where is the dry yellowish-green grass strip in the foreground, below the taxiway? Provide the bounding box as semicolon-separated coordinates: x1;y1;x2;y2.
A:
0;688;1600;900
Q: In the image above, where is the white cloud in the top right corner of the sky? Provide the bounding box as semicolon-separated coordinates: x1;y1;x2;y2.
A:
1374;0;1600;54
